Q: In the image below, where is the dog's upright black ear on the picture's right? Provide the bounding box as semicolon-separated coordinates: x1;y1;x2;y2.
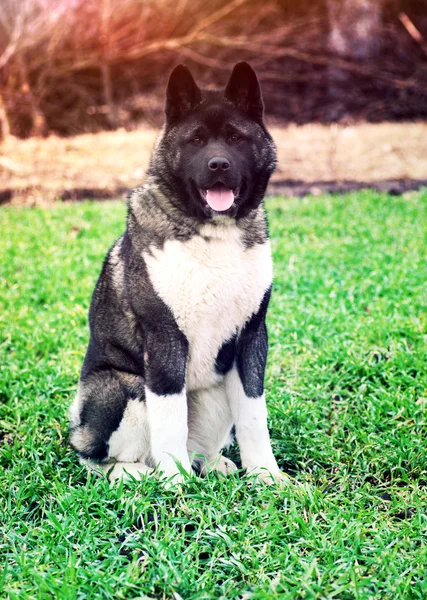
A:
225;61;264;122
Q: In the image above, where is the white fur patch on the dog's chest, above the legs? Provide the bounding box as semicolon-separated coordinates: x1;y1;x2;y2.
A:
144;226;272;390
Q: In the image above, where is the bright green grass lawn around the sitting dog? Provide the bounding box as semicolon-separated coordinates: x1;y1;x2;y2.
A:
0;192;427;600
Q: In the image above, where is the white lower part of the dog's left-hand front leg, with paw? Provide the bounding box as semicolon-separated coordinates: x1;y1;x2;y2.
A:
145;387;191;477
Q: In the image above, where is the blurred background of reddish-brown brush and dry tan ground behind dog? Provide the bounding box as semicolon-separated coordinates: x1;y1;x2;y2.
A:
0;0;427;204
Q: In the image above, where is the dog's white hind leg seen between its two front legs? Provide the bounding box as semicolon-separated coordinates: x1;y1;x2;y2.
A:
187;384;237;475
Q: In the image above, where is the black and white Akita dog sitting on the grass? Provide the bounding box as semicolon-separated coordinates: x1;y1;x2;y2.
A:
70;62;286;483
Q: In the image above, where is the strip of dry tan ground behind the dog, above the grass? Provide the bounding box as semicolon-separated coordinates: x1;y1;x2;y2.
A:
0;123;427;206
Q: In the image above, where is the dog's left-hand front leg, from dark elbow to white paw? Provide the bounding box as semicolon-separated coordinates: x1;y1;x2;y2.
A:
144;325;191;477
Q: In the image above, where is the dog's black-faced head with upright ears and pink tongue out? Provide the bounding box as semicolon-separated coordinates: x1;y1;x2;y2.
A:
154;62;276;219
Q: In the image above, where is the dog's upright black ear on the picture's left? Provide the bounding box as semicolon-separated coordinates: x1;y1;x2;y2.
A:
165;65;202;122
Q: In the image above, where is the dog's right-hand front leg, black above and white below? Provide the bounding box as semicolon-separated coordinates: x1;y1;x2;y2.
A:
226;293;288;483
